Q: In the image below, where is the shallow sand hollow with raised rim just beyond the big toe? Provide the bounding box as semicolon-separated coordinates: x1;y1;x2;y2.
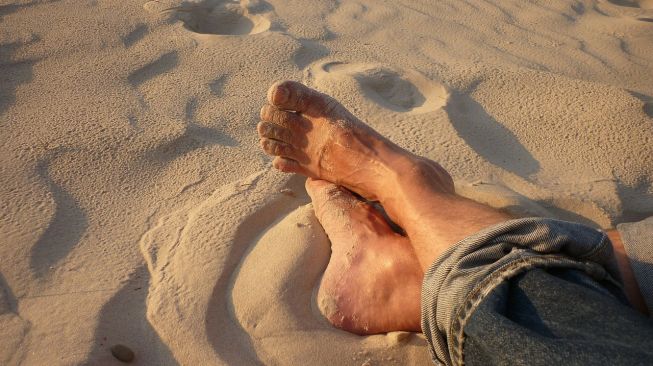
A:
310;62;449;114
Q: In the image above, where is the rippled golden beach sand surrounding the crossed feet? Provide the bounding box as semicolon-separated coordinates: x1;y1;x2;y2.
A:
0;0;653;365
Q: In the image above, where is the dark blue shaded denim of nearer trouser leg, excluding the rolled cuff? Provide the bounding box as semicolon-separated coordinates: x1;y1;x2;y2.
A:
464;269;653;366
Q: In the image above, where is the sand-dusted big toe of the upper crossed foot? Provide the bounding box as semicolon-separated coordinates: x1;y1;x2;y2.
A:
268;80;337;114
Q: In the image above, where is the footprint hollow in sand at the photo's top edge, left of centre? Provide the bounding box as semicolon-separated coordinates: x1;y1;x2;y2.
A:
144;0;270;36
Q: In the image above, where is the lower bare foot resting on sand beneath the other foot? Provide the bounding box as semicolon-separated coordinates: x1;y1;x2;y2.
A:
306;179;424;334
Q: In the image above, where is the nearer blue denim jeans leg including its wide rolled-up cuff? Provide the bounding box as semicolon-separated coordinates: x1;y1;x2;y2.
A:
422;218;653;365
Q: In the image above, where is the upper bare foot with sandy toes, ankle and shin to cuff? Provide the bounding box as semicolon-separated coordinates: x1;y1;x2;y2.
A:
258;81;510;269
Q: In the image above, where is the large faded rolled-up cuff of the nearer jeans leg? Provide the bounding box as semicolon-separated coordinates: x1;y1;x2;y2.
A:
421;218;621;365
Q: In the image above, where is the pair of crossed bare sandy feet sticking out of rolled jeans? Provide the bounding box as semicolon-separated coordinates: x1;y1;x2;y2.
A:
257;81;508;334
